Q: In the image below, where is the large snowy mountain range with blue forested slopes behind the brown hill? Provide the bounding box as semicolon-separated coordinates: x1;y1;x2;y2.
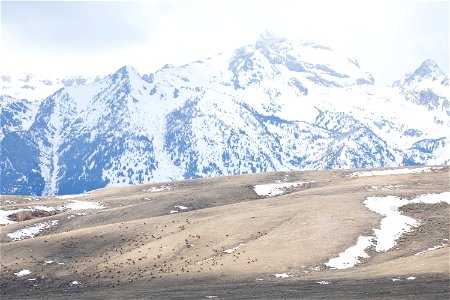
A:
0;33;450;195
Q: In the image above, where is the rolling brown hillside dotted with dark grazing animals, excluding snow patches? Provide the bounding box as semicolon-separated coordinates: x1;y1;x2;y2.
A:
0;166;450;299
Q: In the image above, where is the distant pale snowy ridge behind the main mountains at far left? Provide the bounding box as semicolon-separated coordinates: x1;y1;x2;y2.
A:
0;74;101;101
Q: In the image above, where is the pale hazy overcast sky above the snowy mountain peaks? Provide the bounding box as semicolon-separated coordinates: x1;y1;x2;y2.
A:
0;0;449;84
